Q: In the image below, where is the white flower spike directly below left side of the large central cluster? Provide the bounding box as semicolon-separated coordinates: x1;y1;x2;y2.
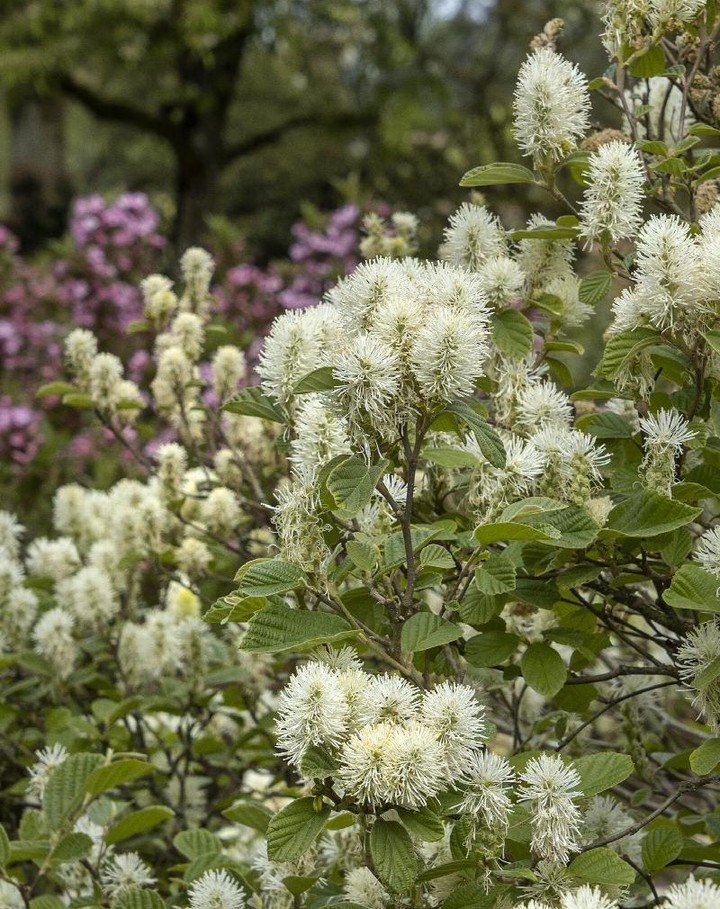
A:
290;394;350;470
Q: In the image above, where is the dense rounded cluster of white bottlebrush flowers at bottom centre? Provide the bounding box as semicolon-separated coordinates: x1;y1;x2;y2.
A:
277;652;485;808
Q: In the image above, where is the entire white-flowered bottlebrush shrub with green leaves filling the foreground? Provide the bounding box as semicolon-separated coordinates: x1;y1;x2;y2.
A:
9;2;720;909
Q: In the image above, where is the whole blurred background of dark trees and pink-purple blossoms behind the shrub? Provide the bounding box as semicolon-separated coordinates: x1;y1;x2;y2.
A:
0;0;608;531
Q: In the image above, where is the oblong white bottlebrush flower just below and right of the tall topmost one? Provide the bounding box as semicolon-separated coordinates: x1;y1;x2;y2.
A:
581;141;645;242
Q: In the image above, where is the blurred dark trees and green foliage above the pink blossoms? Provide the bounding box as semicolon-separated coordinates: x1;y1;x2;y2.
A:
0;0;605;255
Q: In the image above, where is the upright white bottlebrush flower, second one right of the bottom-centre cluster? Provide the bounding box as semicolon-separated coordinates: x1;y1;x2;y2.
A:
517;754;582;863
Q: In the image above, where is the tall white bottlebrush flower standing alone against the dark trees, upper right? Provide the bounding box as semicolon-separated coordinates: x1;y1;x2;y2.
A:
513;47;590;161
